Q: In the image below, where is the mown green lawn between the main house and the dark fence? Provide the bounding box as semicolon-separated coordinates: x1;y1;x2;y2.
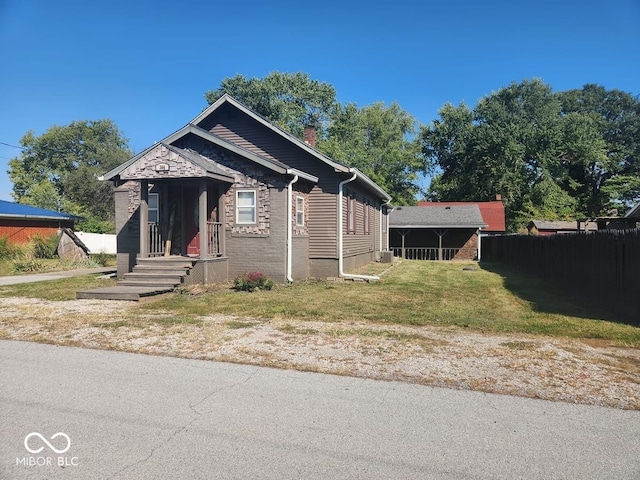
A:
136;261;640;347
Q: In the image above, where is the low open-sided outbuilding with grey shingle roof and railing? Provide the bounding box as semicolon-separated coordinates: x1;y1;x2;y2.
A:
389;203;487;260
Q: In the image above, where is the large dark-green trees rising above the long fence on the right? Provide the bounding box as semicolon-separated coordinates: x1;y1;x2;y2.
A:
420;80;640;231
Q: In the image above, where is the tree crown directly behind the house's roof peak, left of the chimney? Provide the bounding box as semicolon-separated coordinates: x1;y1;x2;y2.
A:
205;72;337;138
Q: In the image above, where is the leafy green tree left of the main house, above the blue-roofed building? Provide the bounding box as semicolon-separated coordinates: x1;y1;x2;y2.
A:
8;120;132;232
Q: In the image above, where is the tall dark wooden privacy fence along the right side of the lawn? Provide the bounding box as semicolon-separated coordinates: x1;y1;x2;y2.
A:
482;229;640;325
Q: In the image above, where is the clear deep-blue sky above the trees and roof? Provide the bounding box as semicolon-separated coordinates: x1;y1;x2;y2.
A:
0;0;640;200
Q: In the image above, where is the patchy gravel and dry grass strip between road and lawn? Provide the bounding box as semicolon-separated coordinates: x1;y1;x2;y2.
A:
0;298;640;410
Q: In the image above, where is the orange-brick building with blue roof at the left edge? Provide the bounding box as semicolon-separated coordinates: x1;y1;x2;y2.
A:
0;200;80;243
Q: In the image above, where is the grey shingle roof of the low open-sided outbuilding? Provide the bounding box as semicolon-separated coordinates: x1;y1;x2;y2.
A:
389;205;487;228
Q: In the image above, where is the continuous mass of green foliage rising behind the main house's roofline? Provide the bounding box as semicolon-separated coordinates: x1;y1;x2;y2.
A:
205;72;425;204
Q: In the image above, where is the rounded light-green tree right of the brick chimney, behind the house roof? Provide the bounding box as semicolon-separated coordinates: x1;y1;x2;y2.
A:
318;102;425;205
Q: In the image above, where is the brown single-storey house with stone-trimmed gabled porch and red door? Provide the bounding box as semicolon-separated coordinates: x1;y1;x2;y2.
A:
103;95;390;283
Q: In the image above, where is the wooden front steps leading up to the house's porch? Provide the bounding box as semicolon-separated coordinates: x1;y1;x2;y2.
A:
76;257;195;301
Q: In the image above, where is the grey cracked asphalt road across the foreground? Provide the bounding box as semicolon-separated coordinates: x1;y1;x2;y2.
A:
0;341;640;480
